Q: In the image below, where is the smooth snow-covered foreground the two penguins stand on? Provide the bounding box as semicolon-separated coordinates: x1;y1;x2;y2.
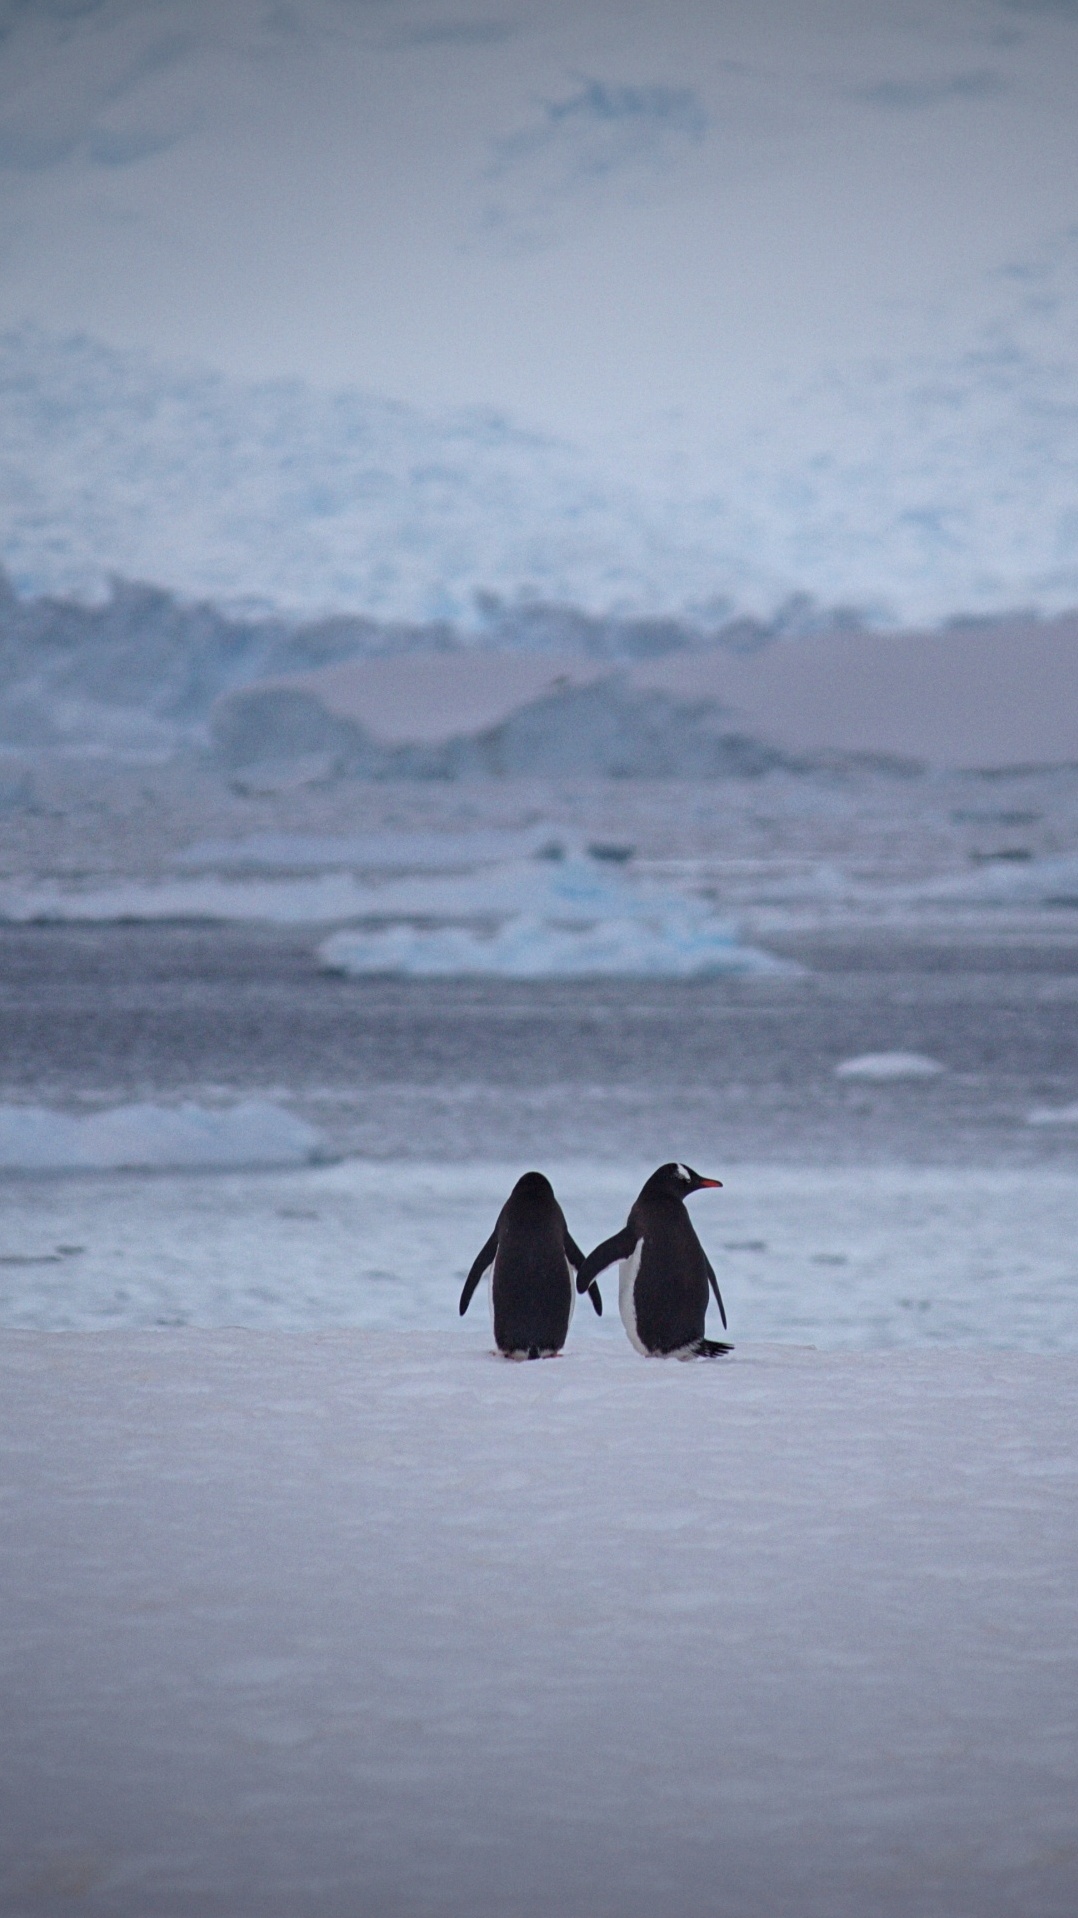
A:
0;1327;1078;1918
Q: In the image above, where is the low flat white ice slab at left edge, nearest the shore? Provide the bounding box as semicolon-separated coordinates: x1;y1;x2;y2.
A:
0;1099;320;1172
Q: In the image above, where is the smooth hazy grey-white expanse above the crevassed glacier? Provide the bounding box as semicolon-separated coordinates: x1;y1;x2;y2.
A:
0;0;1078;450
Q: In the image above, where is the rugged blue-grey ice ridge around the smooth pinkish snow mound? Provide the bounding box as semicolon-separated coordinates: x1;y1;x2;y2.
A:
0;560;813;759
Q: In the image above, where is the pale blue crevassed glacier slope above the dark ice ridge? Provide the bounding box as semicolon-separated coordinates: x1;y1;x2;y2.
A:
0;274;1078;633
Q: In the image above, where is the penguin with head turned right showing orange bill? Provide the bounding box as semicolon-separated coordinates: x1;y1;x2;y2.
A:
577;1164;733;1358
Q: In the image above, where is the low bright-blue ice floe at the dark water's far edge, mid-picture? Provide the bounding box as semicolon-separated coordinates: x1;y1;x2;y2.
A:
318;913;786;978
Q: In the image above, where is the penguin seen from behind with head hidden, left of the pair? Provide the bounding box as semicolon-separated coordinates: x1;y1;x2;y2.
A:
460;1172;602;1358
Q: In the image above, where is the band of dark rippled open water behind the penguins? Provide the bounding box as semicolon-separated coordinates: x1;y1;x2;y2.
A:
0;924;1078;1166
